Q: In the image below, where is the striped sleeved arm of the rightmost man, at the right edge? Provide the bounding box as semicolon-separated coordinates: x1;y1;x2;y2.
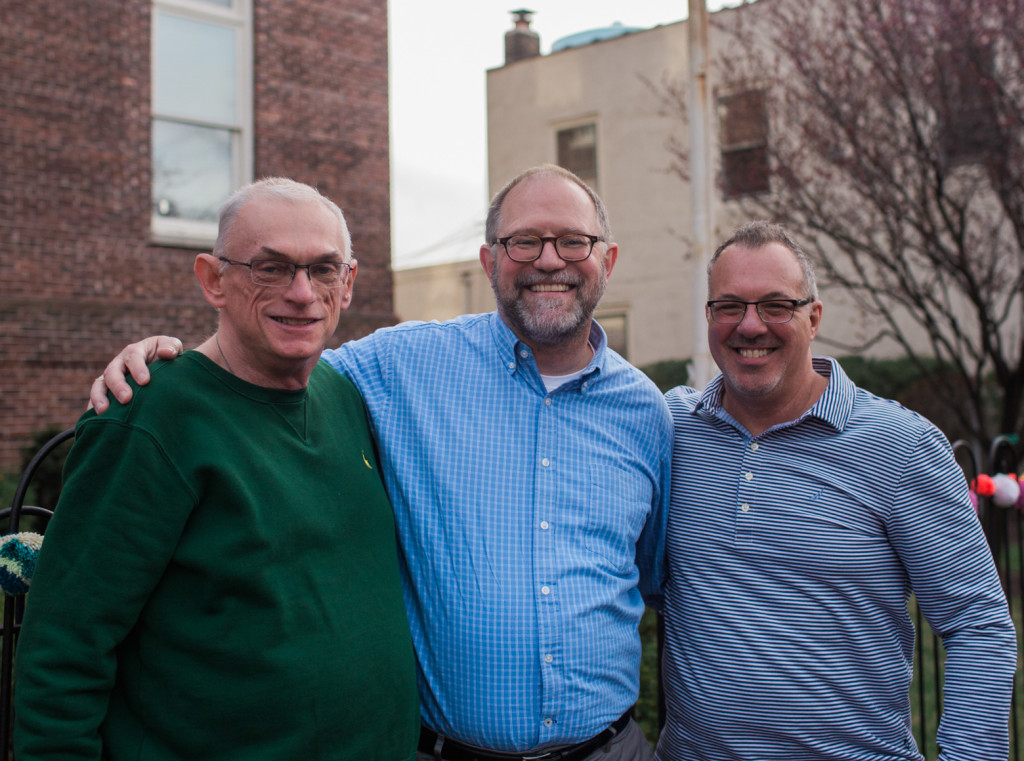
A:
889;432;1017;761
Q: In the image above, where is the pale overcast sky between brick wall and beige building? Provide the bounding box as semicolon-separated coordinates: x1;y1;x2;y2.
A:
388;0;724;268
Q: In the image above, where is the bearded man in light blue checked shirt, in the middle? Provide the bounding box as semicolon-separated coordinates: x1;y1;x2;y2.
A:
92;166;672;761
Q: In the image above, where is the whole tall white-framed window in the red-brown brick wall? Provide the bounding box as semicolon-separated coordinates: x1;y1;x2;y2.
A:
152;0;253;248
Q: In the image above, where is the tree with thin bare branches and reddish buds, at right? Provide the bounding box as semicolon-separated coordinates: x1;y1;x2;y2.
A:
660;0;1024;439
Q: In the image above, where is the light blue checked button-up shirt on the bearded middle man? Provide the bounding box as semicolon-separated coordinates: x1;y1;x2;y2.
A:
324;313;672;751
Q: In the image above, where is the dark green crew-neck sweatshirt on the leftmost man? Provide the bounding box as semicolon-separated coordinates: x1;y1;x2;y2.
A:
14;352;420;761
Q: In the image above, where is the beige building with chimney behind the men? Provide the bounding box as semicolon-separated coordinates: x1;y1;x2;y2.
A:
395;5;888;366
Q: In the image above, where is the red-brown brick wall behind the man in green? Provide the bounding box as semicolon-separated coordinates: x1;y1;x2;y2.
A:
0;0;394;472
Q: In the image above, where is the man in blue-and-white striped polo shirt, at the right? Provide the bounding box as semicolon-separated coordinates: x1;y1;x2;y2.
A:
656;222;1017;761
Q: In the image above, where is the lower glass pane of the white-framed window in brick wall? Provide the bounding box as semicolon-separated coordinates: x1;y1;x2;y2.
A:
153;119;232;221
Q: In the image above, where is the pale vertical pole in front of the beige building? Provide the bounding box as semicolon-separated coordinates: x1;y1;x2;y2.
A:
686;0;713;388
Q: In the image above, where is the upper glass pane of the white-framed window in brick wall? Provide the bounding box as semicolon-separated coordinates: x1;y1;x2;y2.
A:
153;12;238;124
